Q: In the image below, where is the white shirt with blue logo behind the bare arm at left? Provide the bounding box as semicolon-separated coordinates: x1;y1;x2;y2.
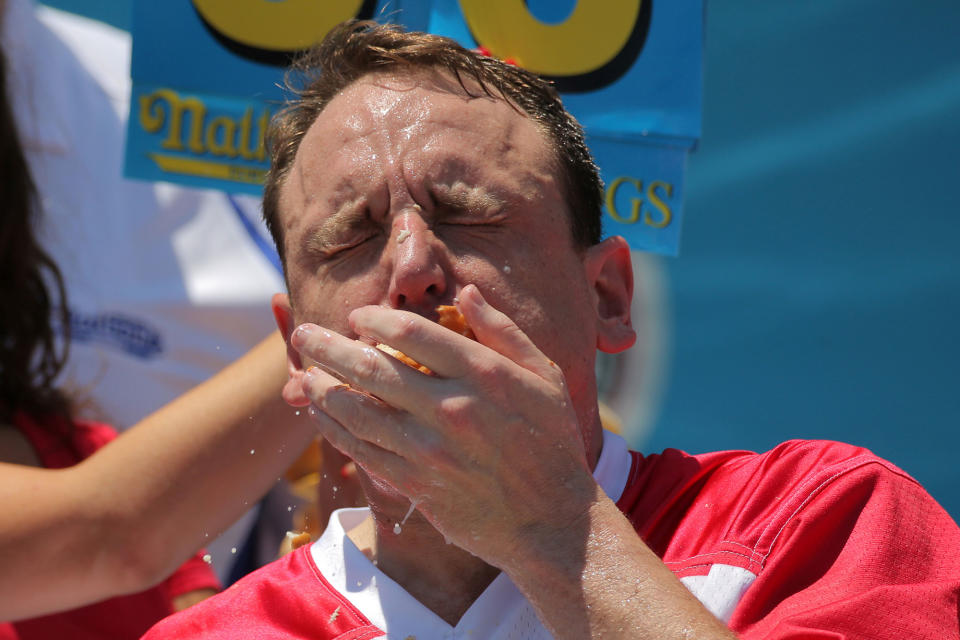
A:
2;0;283;577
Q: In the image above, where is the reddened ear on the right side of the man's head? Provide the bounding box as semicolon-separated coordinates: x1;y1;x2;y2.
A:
583;236;637;353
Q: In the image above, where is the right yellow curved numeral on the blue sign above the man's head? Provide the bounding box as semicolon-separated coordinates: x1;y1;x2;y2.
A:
460;0;650;76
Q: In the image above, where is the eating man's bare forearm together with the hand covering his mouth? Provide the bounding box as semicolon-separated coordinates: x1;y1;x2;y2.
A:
292;287;734;639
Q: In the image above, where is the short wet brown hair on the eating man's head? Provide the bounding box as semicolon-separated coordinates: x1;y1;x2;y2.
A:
263;20;603;264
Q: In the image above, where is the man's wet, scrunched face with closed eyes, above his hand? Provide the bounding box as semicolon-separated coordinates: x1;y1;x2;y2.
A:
280;74;597;410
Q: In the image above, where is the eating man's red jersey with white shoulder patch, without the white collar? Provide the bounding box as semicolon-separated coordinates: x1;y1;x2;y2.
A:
146;441;960;640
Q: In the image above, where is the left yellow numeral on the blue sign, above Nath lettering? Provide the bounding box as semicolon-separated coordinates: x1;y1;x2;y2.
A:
193;0;363;51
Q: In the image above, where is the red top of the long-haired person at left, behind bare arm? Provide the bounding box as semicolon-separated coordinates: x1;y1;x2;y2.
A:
0;413;220;640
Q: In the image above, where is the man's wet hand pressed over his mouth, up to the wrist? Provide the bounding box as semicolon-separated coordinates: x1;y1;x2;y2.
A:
292;286;597;568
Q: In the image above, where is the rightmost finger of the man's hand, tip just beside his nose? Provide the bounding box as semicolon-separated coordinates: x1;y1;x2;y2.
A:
457;284;563;381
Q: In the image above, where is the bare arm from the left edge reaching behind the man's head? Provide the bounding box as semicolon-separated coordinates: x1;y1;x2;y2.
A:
0;334;315;620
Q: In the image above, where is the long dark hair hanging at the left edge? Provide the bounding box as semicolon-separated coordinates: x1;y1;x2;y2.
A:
0;50;70;422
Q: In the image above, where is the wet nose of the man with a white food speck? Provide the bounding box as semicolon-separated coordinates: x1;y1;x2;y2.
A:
388;213;447;314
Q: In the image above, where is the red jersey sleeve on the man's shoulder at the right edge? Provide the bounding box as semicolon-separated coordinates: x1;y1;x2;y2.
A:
729;458;960;640
